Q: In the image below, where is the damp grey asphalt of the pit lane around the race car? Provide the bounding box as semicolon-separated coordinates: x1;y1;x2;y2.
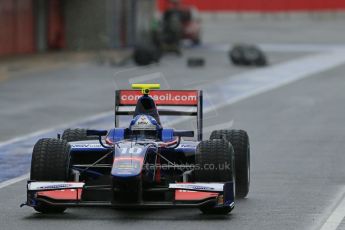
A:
0;15;345;230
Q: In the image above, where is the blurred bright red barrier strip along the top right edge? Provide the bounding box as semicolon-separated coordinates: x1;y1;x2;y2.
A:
157;0;345;13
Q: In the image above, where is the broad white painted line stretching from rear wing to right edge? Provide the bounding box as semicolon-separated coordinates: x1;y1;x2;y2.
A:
168;49;345;126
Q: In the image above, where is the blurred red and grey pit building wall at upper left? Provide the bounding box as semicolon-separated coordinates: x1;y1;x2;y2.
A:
0;0;156;57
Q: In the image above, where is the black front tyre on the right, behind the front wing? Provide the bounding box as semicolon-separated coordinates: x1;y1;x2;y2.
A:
195;139;234;215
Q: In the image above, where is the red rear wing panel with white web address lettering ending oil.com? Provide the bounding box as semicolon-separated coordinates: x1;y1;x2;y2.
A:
120;90;198;105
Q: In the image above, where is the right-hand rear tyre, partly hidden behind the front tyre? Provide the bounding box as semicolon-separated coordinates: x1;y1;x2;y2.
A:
210;130;250;198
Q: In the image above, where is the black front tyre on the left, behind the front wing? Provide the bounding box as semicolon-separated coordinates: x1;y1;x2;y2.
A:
30;138;70;213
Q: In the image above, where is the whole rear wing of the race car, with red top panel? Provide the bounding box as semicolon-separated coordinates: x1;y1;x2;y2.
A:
115;90;202;141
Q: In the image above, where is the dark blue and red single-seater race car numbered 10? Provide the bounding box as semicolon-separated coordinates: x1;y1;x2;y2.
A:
23;84;250;214
